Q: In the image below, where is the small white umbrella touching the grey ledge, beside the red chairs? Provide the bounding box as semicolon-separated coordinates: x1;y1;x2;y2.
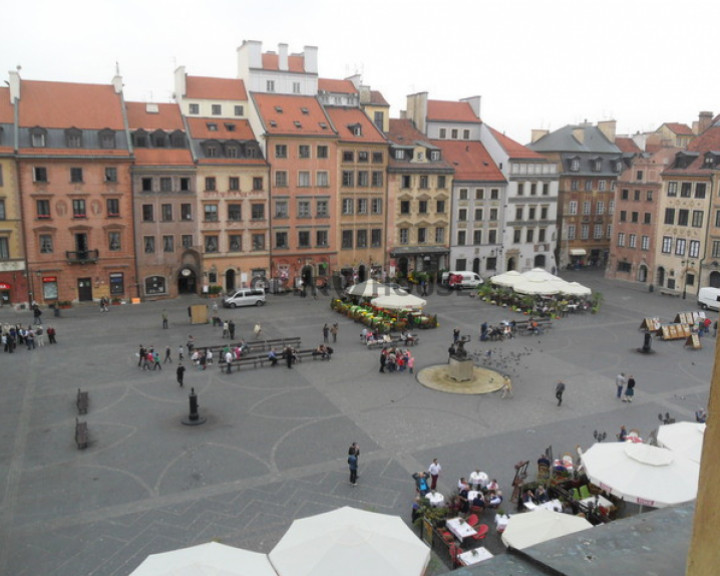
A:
502;508;593;550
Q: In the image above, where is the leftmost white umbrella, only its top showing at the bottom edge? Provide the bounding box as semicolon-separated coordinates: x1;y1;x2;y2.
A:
130;542;277;576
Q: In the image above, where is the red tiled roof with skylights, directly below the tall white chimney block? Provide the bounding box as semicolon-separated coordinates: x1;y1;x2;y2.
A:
251;92;336;136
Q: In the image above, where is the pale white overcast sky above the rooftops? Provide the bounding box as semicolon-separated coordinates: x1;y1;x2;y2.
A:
0;0;720;143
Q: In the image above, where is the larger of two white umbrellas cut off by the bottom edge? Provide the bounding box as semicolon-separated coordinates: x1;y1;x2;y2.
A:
269;506;430;576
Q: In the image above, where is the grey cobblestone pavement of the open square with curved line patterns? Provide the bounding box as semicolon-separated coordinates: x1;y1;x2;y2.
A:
0;272;716;576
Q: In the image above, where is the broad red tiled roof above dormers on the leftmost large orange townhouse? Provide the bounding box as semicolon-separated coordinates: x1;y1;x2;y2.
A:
20;80;125;130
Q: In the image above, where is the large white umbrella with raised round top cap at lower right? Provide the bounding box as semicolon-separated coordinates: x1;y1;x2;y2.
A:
581;442;700;508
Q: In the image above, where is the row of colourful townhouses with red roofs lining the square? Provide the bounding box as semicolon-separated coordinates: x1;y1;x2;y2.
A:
0;41;720;304
